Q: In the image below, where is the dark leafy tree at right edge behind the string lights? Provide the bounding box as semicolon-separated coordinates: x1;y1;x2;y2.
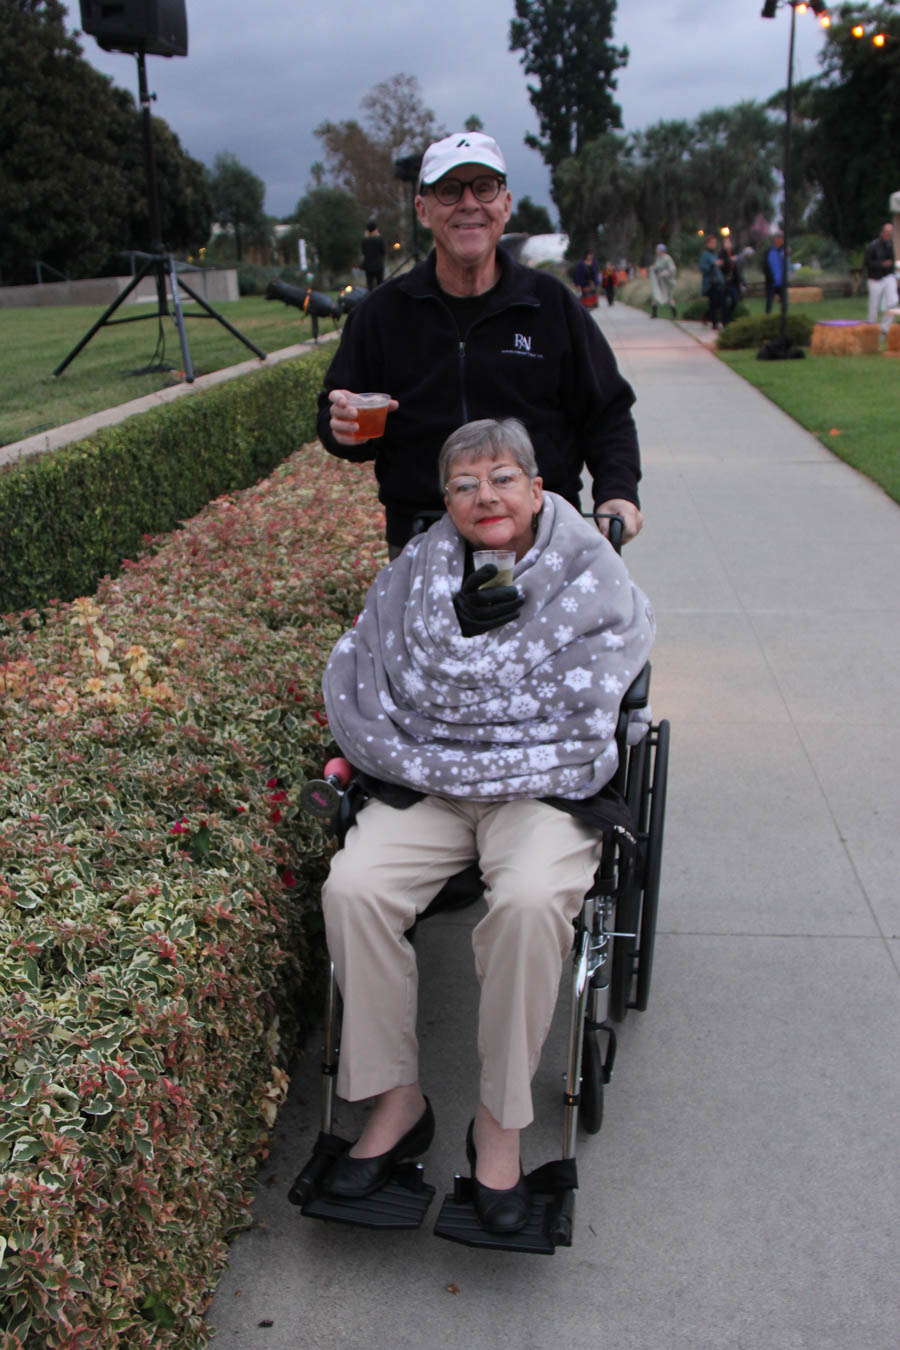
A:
808;4;900;248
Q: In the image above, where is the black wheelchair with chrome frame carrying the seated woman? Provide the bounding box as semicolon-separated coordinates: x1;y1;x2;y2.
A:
287;510;669;1254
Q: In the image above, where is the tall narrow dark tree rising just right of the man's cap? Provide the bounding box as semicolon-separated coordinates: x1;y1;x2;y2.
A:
510;0;629;171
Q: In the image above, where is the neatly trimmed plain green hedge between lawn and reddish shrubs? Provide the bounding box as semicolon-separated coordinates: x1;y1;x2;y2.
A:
0;350;332;614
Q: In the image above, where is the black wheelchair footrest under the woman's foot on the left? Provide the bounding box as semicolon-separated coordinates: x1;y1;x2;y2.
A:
287;1134;434;1229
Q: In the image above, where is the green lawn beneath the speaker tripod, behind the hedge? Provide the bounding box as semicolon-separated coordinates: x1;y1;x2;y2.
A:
0;296;333;446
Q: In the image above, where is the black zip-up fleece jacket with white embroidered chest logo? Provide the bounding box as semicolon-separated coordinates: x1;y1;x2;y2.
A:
317;248;641;545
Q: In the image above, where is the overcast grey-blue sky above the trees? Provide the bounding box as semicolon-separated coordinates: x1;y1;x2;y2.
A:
69;0;823;226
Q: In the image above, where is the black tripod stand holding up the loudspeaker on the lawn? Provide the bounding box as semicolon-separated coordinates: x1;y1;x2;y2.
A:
54;51;266;383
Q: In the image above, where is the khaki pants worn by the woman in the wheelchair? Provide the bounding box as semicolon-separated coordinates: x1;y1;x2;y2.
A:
322;797;600;1129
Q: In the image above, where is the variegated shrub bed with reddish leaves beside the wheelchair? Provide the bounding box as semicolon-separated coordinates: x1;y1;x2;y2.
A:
0;447;383;1350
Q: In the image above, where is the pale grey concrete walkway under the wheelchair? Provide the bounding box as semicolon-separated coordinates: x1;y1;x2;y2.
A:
209;305;900;1350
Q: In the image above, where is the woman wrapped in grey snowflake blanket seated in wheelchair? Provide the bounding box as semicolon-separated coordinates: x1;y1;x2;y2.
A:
322;420;654;1233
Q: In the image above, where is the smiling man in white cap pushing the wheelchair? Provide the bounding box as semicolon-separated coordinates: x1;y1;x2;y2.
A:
318;132;642;556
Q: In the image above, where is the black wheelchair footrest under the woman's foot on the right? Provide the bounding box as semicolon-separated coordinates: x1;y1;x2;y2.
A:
434;1158;578;1257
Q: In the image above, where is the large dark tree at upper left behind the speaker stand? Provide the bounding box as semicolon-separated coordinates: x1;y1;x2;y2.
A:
0;0;212;284
